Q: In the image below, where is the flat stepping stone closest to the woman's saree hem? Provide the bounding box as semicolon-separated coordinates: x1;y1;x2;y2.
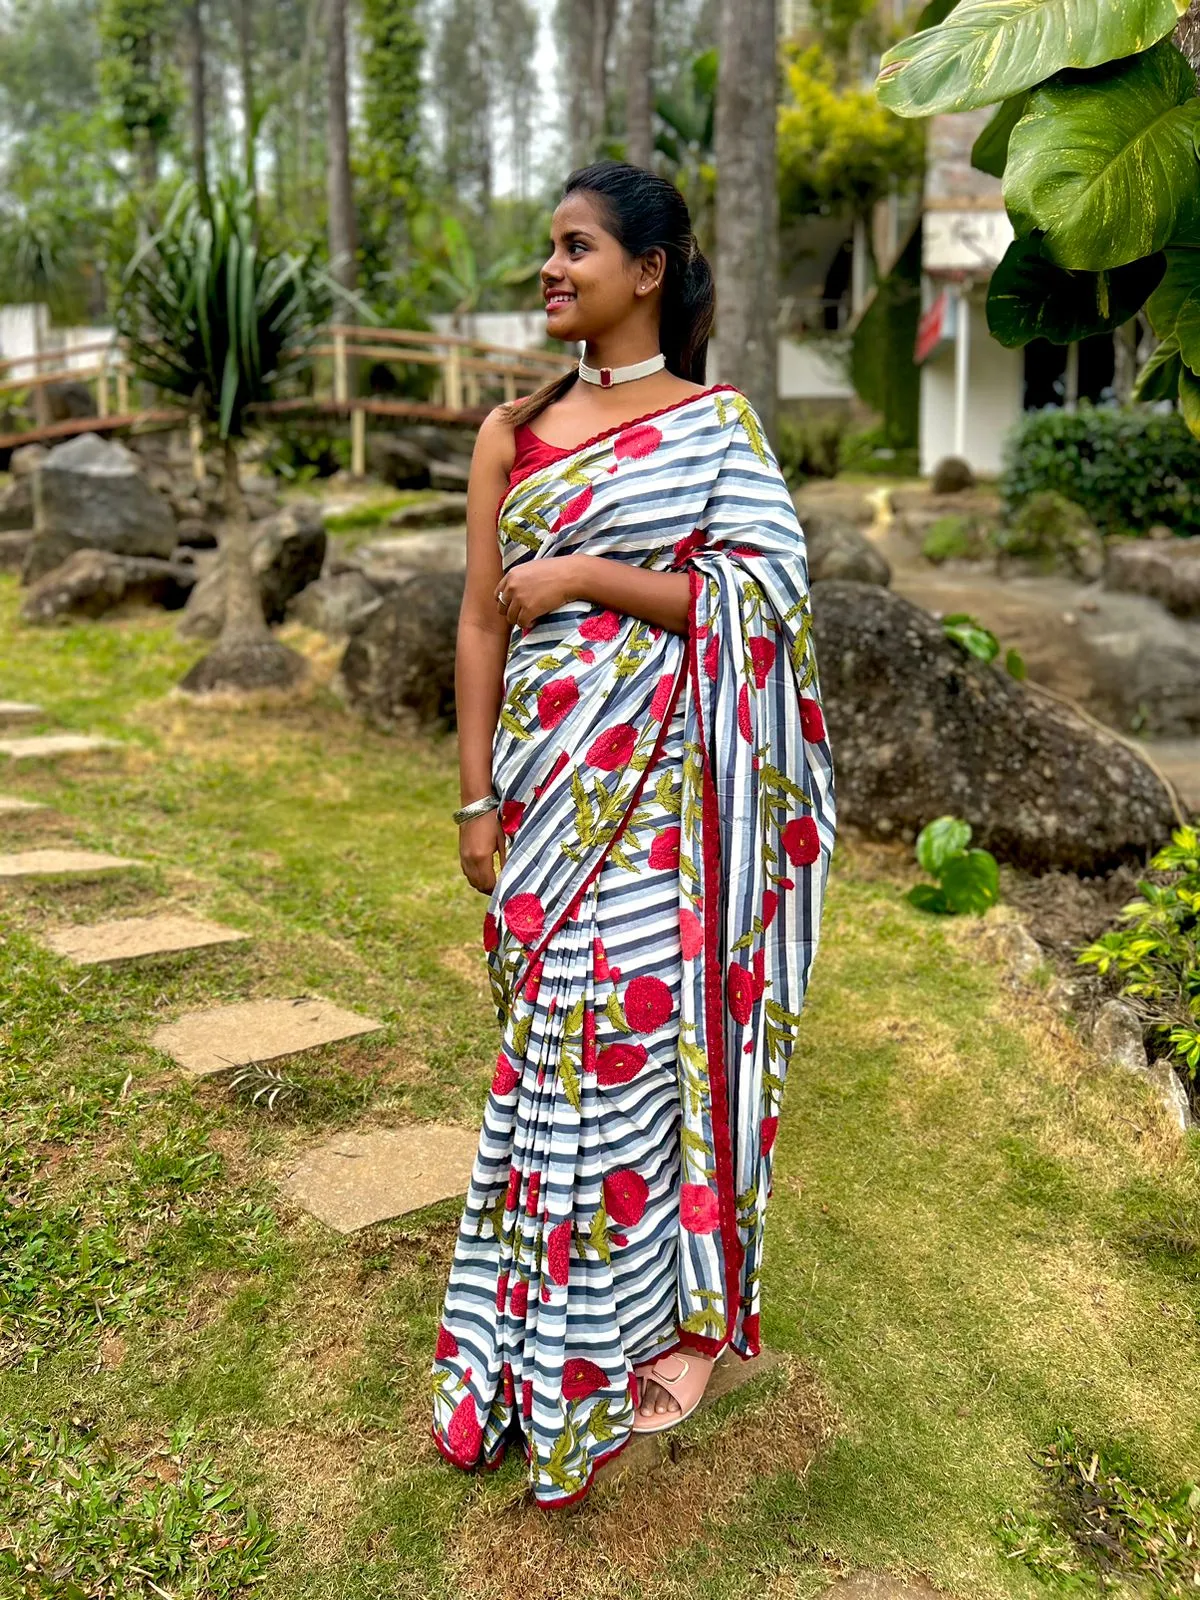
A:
280;1122;478;1234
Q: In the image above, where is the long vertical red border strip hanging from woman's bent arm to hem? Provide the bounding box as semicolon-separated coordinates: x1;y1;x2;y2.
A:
680;566;746;1354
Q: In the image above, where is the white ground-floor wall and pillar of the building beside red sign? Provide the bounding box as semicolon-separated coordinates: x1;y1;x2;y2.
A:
920;290;1024;477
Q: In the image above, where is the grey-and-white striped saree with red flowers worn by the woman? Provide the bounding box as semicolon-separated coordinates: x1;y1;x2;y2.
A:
432;384;835;1506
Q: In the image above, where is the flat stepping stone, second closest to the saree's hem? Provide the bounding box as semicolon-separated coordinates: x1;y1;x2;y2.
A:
150;995;384;1078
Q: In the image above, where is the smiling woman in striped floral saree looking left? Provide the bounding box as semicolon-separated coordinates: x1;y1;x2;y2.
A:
432;162;835;1506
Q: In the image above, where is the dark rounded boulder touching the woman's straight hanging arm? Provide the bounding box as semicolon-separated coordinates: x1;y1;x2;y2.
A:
334;573;464;728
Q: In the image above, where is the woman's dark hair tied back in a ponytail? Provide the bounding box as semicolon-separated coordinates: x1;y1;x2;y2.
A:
507;162;717;424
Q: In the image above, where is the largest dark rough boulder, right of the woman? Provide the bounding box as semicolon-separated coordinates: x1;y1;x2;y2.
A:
813;582;1174;874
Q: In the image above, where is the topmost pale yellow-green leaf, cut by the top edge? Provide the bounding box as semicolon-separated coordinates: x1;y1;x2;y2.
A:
877;0;1187;117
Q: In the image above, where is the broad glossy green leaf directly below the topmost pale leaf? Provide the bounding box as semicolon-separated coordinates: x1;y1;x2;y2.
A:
1005;43;1200;272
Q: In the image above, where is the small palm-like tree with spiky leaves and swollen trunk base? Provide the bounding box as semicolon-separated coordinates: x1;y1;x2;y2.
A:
115;178;333;693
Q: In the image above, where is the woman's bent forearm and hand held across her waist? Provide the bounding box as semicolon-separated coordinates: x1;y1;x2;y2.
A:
493;555;691;634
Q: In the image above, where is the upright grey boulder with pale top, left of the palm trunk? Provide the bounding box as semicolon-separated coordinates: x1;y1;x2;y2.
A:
18;434;176;582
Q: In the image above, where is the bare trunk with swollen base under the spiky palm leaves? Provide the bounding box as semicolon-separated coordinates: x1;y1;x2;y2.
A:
179;438;309;694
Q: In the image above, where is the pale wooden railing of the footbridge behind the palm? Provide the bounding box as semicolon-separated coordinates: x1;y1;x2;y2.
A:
0;323;570;464
